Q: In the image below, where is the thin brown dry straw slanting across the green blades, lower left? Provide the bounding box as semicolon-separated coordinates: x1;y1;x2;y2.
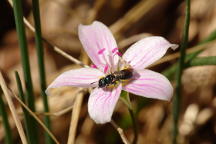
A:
12;91;60;144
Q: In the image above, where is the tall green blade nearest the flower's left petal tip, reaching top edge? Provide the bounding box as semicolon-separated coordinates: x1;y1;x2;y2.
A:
32;0;53;144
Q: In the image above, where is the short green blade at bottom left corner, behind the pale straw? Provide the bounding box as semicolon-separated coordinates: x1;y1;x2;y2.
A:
0;87;13;144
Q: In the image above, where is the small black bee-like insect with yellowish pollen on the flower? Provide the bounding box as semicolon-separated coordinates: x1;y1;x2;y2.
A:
98;68;133;88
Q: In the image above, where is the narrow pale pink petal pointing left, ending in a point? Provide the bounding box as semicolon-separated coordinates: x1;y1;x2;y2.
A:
47;68;104;90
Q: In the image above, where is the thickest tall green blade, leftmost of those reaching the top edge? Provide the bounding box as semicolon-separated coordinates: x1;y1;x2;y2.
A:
13;0;38;144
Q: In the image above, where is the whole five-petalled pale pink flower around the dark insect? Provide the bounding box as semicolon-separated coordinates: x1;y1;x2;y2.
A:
48;21;178;124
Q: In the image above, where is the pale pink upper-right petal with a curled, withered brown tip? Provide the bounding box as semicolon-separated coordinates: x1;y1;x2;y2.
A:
123;36;178;69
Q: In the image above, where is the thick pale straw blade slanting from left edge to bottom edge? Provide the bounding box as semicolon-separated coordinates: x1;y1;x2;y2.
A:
0;71;27;144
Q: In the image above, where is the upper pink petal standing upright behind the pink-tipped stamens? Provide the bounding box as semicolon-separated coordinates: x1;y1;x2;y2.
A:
78;21;118;71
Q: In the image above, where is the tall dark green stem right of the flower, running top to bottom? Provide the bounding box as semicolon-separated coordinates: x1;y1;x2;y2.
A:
172;0;190;144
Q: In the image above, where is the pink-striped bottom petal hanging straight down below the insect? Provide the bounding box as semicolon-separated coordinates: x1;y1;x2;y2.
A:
88;85;122;124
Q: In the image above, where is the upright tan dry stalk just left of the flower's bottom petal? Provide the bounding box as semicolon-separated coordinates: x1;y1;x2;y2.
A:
67;89;84;144
